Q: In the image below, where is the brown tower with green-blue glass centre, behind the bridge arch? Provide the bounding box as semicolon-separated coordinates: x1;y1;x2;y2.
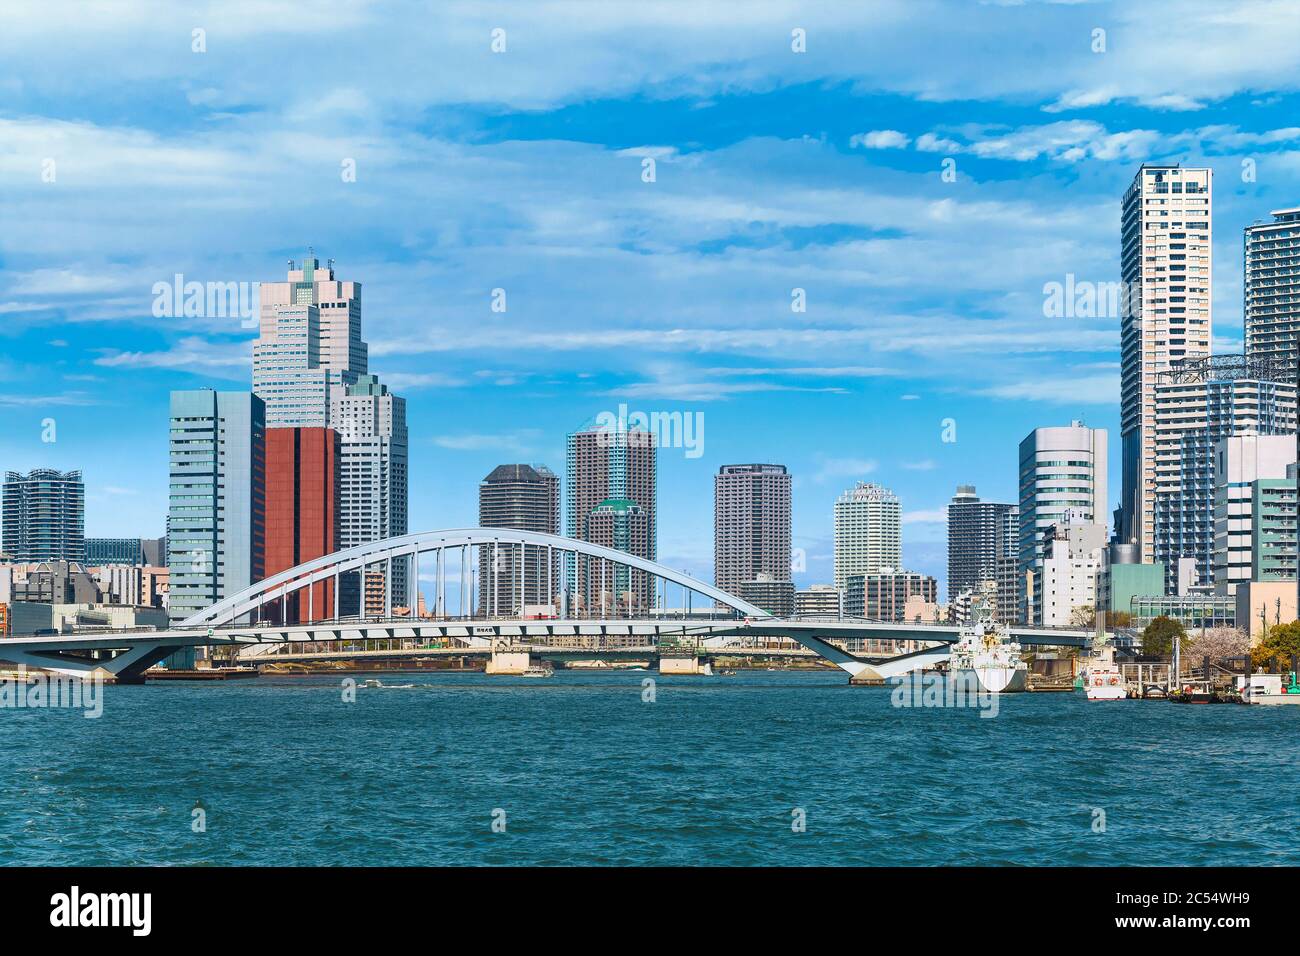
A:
564;423;658;610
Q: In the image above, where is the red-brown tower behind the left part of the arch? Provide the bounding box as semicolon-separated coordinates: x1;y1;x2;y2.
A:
264;428;339;624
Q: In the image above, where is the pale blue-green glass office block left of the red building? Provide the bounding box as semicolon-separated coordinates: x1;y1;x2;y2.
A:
168;389;267;620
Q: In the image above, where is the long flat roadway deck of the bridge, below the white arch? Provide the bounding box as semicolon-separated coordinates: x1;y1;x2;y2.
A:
0;617;1092;682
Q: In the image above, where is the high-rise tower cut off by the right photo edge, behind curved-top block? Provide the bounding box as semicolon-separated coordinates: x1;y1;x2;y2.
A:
1244;207;1300;368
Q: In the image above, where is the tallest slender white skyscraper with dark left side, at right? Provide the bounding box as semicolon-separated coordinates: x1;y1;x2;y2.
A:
1115;165;1213;563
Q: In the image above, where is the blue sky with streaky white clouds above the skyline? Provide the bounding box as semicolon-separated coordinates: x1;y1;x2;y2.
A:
0;0;1300;595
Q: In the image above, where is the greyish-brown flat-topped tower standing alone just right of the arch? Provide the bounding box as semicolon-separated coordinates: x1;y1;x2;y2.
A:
714;464;790;596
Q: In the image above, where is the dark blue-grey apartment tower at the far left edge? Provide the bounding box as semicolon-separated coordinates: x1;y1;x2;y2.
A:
3;468;86;562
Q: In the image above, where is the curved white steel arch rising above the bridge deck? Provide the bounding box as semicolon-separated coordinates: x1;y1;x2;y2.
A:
179;528;771;627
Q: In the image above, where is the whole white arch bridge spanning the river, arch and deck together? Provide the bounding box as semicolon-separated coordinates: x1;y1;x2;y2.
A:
0;528;1092;682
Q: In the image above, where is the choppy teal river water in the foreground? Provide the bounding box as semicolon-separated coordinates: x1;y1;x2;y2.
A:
0;671;1300;865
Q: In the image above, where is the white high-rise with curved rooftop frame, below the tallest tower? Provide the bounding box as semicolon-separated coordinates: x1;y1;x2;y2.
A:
1153;355;1296;593
